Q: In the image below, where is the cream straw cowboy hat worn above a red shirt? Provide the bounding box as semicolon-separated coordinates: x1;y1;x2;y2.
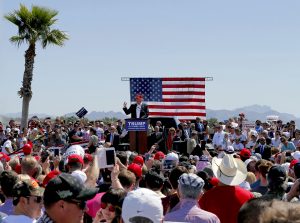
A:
212;154;247;186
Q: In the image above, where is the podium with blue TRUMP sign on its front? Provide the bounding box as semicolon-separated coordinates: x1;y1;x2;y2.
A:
125;118;148;154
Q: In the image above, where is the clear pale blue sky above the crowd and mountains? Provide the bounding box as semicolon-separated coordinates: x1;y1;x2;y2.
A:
0;0;300;117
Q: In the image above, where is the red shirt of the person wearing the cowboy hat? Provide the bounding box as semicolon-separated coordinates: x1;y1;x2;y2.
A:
199;186;253;223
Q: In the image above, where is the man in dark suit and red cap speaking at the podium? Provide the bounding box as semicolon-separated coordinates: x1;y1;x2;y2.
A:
123;94;149;118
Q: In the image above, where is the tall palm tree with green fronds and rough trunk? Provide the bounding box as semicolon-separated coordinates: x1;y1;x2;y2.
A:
4;4;68;128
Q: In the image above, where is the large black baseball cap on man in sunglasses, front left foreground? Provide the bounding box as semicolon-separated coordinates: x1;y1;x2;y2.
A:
44;173;98;204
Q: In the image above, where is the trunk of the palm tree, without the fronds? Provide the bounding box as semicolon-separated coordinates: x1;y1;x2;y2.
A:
18;43;35;129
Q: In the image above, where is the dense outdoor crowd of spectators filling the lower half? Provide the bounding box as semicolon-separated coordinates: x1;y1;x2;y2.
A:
0;112;300;223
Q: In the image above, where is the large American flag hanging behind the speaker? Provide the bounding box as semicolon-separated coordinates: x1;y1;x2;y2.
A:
130;77;206;120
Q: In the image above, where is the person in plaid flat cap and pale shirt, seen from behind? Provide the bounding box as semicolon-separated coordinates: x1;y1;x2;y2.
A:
164;173;220;223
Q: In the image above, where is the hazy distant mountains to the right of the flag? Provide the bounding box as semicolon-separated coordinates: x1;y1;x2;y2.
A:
206;105;300;126
